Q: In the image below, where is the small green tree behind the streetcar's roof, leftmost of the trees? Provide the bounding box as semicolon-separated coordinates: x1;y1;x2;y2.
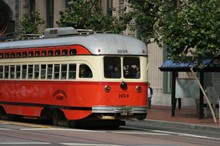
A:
19;11;45;34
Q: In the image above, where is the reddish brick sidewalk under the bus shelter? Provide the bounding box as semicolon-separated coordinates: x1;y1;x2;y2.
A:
145;106;220;131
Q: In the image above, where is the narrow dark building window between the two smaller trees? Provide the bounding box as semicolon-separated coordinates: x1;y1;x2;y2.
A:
46;0;54;28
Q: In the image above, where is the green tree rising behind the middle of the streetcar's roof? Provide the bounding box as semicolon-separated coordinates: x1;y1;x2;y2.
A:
57;0;131;33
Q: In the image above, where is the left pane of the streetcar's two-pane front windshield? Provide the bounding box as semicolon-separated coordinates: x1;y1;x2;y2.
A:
104;57;121;78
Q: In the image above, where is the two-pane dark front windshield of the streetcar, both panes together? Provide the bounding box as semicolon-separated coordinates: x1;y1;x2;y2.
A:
104;57;140;79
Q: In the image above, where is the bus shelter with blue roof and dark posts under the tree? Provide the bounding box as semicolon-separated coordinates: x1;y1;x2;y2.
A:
159;56;220;119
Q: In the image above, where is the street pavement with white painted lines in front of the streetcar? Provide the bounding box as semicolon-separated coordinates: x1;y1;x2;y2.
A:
0;120;220;146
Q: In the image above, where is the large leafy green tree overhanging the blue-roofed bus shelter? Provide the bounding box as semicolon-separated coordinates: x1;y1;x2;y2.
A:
130;0;220;68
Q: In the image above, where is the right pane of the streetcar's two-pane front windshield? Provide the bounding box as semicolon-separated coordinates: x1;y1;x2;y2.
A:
123;57;140;79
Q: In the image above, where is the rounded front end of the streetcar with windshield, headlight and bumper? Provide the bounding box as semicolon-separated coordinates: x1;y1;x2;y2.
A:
87;35;147;120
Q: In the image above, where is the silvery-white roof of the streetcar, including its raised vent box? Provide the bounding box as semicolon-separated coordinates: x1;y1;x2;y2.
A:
0;27;147;55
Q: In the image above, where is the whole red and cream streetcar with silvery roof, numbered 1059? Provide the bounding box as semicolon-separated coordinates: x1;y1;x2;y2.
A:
0;27;147;126
